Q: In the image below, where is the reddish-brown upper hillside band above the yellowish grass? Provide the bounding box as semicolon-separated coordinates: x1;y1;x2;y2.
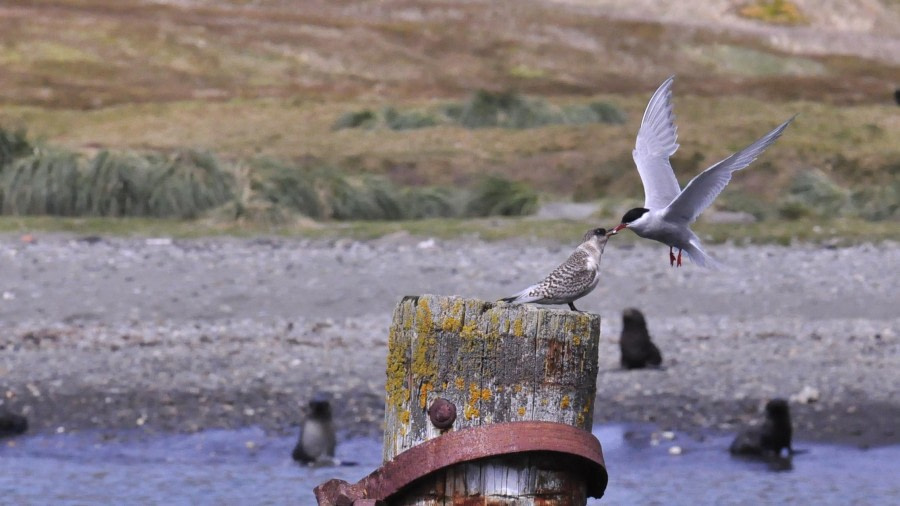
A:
0;0;897;109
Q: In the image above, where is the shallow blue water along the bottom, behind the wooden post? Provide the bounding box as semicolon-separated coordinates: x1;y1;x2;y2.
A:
0;425;900;505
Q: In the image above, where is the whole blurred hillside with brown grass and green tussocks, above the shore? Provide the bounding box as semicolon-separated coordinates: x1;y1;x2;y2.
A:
0;0;900;237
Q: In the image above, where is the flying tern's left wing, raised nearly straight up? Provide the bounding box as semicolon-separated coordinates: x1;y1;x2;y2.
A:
631;76;681;209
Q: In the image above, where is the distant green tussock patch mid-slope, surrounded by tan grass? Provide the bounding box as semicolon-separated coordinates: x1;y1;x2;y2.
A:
331;90;626;130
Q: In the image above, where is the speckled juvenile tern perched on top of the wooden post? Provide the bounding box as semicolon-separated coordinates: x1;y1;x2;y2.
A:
500;228;609;311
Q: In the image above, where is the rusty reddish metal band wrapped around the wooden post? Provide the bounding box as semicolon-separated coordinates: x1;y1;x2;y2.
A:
315;422;609;506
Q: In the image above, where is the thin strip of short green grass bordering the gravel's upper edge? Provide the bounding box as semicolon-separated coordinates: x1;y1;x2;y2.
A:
0;212;900;245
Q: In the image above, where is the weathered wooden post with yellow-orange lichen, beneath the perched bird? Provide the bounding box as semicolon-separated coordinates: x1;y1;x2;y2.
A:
384;295;600;505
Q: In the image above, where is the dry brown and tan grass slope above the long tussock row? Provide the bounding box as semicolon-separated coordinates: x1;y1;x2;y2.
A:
0;0;900;221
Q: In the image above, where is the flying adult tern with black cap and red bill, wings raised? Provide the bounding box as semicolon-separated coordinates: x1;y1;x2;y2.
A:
612;76;794;267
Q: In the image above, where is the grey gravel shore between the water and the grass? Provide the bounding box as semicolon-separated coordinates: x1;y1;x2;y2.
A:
0;234;900;446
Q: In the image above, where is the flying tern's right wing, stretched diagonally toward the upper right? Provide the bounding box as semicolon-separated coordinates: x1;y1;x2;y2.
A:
663;116;796;224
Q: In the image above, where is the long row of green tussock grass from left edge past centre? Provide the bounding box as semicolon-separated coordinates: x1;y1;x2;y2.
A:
0;130;537;223
